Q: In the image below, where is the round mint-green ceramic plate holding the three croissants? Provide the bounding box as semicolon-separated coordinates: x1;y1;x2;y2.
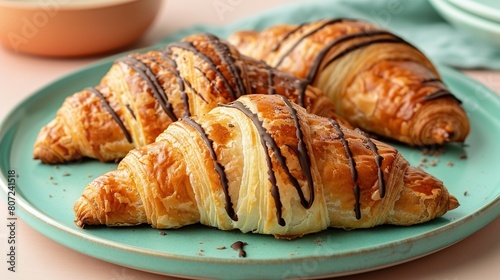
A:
0;54;500;279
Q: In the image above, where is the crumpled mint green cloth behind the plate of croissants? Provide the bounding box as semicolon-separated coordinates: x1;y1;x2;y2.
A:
161;0;500;69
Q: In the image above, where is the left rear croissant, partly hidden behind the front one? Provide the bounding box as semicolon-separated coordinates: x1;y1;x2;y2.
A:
33;34;348;163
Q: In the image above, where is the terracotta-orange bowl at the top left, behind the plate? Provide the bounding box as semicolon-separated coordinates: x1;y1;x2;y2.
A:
0;0;162;57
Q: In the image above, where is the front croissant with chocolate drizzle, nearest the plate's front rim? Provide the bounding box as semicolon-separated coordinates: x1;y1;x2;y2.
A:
74;95;459;239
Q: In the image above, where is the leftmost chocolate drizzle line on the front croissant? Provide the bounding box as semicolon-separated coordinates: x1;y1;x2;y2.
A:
182;118;238;221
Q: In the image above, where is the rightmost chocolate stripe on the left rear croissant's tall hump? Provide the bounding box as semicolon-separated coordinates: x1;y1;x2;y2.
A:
203;33;247;97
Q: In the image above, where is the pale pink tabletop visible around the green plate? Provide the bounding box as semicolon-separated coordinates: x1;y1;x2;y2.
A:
0;0;500;280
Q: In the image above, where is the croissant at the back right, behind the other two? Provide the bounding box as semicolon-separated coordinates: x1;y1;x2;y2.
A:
228;18;470;146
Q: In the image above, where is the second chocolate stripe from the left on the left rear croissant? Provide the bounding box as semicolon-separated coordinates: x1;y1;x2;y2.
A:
119;56;177;121
